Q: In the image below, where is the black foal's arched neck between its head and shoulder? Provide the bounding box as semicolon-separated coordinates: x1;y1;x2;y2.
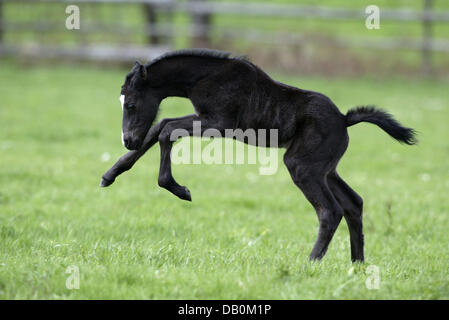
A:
148;56;229;98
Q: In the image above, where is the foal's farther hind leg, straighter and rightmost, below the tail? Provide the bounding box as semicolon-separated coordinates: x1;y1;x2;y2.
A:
327;171;364;262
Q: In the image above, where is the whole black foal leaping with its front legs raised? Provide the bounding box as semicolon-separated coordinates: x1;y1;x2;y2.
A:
100;49;416;261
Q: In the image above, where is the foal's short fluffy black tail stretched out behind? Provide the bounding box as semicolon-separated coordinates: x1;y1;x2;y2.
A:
346;106;418;145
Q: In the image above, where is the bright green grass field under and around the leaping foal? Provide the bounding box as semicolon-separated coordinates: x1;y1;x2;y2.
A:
0;62;449;299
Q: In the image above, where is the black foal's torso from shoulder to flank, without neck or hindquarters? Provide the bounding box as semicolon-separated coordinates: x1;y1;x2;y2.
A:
189;59;314;143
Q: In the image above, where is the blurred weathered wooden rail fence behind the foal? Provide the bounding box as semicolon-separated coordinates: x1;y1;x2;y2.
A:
0;0;449;73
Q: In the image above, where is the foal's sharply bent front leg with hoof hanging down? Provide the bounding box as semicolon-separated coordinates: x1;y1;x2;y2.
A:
158;115;221;201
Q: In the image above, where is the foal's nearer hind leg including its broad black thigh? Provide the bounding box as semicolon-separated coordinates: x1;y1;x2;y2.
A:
284;117;348;260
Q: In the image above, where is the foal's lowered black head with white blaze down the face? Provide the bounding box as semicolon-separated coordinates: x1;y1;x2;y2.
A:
120;62;161;150
